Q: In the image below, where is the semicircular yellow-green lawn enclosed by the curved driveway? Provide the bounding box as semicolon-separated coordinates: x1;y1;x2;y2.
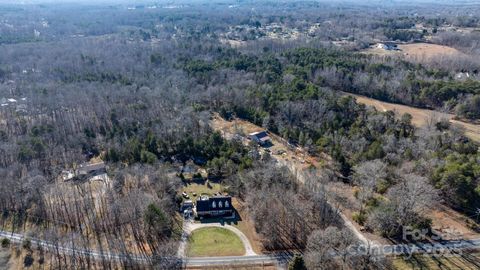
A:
187;227;245;257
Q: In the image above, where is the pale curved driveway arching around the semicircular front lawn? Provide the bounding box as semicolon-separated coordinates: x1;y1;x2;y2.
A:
178;220;257;258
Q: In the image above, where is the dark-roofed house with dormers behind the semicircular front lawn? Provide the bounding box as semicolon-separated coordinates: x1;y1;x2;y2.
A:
195;196;233;217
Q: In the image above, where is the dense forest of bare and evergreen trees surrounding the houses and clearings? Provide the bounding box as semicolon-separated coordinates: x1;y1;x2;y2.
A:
0;1;480;269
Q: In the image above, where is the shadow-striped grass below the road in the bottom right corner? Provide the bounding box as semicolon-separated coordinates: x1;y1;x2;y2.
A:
393;252;480;270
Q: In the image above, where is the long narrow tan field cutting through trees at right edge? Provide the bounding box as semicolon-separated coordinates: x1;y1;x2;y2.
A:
348;94;480;142
